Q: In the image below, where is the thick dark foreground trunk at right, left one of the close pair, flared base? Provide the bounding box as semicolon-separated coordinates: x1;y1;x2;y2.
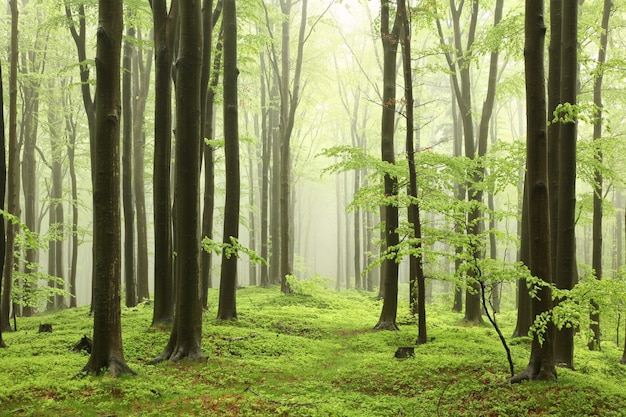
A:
509;0;556;382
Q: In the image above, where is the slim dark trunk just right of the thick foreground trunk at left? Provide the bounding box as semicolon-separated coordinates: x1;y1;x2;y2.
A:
122;23;137;307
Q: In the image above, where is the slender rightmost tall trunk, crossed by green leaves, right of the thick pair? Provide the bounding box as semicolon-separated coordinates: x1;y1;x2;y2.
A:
589;0;613;350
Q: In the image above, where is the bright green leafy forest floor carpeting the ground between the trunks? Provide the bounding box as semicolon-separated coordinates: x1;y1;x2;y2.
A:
0;283;626;417
